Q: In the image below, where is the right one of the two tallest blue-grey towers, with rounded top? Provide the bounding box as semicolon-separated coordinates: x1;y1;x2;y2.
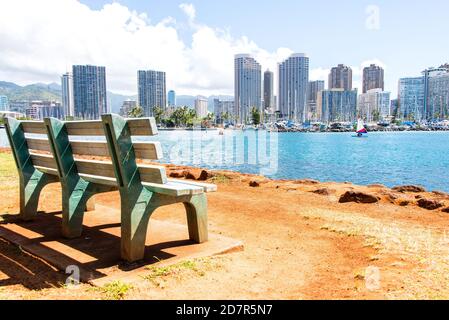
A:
279;53;309;122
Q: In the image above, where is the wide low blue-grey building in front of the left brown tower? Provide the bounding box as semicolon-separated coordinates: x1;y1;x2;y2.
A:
317;89;357;123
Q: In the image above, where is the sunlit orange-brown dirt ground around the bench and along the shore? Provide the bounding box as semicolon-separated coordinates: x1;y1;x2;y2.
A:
0;151;449;299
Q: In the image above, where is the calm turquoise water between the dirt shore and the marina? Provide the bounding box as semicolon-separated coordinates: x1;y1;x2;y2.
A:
0;129;449;192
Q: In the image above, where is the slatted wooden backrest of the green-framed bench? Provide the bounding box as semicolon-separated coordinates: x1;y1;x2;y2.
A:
6;118;167;183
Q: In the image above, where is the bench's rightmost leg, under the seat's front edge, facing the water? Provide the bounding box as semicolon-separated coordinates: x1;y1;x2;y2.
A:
184;193;207;243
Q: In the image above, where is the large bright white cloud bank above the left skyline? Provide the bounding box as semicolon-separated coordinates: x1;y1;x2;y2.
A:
0;0;320;95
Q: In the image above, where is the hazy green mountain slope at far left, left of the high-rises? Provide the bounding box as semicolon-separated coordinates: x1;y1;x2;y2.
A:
0;81;61;101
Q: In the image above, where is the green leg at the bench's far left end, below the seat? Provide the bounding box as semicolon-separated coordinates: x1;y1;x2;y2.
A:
20;170;56;221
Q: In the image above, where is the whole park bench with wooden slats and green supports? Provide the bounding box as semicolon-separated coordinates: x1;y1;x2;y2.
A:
6;114;216;262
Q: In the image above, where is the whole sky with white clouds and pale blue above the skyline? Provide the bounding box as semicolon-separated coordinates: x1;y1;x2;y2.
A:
0;0;449;96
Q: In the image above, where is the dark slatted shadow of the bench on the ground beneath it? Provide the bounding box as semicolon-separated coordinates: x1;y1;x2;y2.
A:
0;212;194;289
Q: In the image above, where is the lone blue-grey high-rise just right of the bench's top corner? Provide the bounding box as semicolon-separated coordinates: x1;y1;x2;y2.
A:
138;70;167;116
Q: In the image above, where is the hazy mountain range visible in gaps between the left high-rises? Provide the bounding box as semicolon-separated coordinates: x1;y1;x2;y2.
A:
0;81;233;113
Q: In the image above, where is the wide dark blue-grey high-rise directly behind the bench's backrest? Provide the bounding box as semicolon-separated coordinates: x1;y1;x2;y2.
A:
73;65;108;120
